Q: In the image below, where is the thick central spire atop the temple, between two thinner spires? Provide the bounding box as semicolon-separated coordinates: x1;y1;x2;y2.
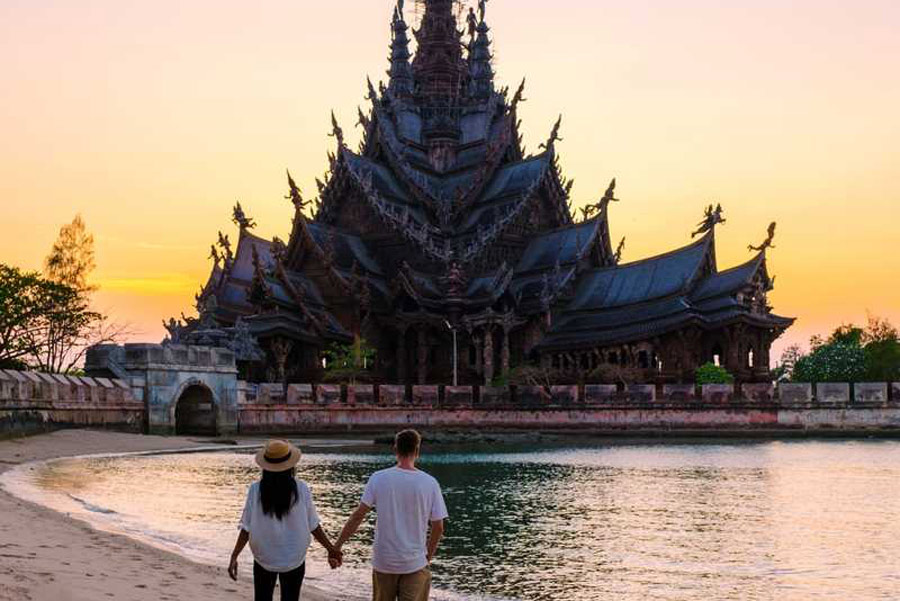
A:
412;0;467;97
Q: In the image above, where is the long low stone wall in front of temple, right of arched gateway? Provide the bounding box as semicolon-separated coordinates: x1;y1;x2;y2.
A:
238;383;900;434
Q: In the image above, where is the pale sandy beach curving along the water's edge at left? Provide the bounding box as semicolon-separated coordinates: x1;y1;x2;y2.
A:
0;430;333;601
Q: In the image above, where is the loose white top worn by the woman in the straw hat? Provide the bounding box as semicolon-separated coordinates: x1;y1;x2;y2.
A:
238;480;319;572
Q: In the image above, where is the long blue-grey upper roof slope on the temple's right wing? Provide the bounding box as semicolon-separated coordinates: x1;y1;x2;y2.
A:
566;237;712;311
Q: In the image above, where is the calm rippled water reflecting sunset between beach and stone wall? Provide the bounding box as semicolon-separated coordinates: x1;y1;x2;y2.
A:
10;442;900;601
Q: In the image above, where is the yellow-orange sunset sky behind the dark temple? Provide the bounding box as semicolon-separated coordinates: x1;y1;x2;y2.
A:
0;0;900;356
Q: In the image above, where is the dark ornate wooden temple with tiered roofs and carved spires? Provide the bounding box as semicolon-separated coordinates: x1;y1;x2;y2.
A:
167;0;793;383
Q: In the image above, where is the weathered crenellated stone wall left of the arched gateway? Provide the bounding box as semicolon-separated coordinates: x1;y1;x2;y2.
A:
0;370;145;436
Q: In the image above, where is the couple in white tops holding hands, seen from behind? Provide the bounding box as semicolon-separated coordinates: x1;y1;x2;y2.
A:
228;430;447;601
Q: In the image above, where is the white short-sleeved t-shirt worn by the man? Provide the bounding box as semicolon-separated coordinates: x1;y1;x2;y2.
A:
362;467;447;574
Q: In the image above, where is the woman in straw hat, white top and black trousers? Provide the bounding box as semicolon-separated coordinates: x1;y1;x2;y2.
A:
228;440;341;601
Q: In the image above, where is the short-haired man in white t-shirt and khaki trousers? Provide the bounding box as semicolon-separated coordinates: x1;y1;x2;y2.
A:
335;430;447;601
